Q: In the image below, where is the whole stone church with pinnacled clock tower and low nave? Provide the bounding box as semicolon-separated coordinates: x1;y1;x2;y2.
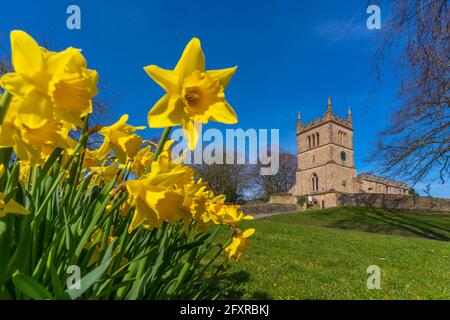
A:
290;98;409;208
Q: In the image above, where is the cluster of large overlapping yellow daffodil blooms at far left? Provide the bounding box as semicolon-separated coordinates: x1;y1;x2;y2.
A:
0;31;98;165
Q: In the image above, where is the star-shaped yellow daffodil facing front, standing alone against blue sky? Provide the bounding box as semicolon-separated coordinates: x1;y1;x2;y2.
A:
144;38;237;150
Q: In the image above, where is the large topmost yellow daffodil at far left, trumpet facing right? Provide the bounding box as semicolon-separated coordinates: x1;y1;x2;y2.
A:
0;30;98;129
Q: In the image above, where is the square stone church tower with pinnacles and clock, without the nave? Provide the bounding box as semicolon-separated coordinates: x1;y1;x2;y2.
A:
291;98;359;196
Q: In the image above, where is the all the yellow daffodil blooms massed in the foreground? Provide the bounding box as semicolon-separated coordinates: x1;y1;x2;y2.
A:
0;31;255;261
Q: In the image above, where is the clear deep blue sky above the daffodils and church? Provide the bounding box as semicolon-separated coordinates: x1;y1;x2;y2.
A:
0;0;450;196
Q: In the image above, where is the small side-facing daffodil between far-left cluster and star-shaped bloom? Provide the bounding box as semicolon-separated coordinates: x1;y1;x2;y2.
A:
97;114;145;164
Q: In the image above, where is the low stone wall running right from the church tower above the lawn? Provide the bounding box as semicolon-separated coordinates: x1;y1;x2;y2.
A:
337;193;450;212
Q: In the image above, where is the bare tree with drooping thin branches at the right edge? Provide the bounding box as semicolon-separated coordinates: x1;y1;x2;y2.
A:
372;0;450;184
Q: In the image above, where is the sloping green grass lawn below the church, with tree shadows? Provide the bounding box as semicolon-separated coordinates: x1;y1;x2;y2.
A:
218;207;450;299
